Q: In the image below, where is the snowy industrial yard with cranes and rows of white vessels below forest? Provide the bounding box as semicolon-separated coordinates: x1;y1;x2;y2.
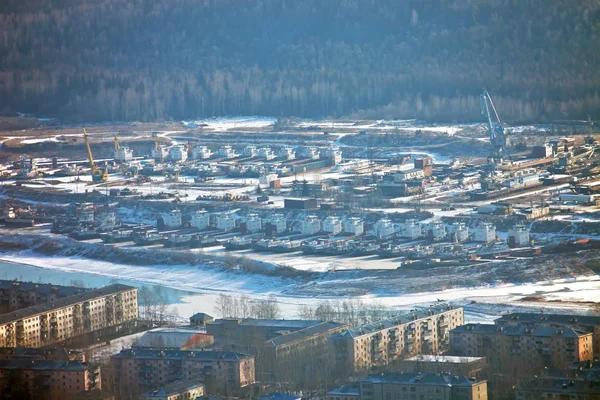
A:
0;103;600;306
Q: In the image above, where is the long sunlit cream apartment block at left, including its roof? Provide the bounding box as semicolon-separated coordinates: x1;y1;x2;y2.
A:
0;285;138;347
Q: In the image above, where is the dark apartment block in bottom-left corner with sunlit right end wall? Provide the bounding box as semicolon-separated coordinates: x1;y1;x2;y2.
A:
0;360;101;400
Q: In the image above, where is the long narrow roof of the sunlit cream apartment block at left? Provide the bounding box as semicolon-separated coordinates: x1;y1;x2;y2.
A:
0;284;137;325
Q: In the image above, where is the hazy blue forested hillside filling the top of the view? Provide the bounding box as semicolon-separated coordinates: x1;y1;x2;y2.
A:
0;0;600;122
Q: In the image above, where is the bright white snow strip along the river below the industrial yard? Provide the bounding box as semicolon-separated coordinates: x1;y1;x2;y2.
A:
2;254;600;321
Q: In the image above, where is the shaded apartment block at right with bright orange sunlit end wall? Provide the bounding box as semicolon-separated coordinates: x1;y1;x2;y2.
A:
450;324;593;375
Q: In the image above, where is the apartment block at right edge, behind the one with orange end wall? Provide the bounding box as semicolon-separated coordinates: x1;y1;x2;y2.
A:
494;313;600;357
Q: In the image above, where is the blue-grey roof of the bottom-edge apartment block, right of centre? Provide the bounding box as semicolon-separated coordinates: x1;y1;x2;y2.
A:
360;372;483;387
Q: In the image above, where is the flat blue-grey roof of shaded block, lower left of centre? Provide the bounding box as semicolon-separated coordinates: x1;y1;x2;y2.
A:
111;349;254;361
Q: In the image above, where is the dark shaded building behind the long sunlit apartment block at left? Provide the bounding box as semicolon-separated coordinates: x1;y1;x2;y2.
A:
0;280;89;314
